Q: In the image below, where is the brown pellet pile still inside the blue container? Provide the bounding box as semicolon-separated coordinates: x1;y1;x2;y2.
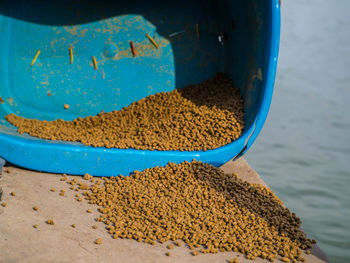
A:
5;73;244;151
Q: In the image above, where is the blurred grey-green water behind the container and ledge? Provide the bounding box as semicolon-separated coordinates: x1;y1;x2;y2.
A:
245;0;350;263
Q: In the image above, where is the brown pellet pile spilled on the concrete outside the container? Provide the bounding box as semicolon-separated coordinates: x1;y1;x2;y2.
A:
67;161;312;262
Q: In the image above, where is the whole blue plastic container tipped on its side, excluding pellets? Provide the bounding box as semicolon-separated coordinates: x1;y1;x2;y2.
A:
0;0;280;176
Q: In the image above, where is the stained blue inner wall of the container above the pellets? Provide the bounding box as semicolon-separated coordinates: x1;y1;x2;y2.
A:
0;0;264;136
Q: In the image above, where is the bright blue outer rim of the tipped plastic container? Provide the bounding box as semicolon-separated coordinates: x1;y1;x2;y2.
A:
0;0;280;176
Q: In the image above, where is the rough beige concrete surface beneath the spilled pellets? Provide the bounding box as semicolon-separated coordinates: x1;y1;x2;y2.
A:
0;158;328;263
